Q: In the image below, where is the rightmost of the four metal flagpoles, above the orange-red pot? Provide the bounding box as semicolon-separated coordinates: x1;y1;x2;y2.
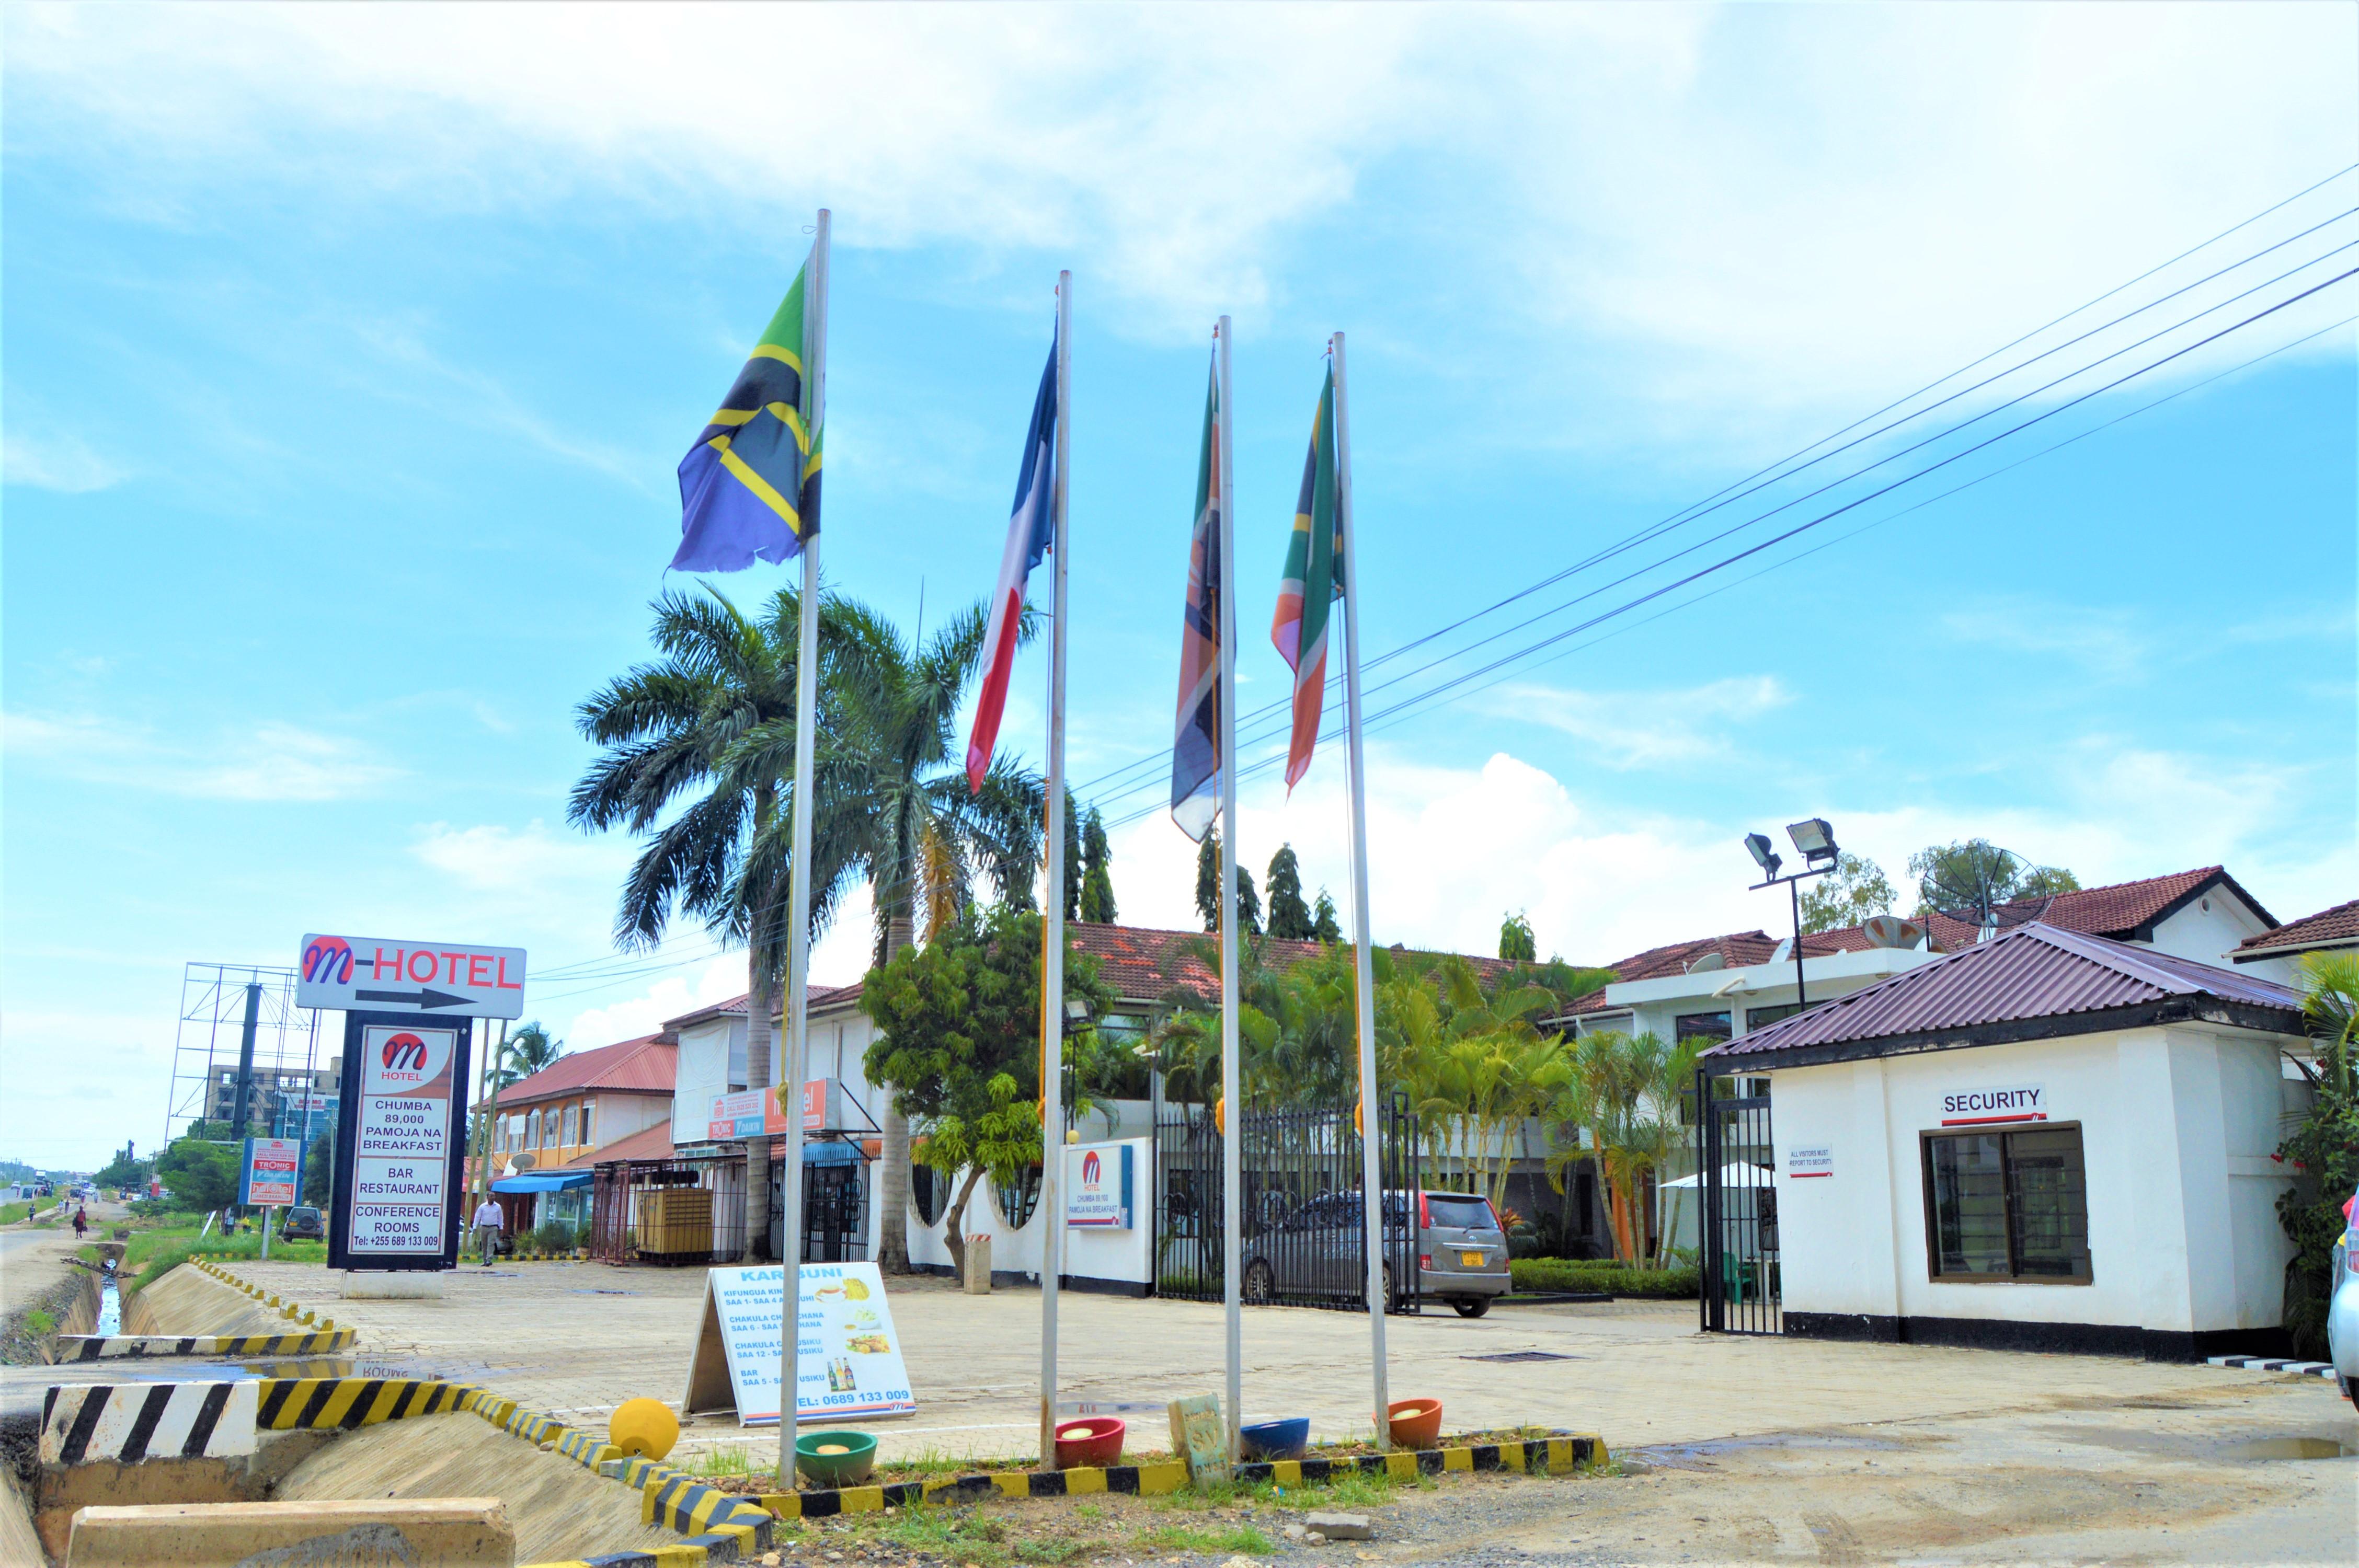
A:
1328;332;1378;1448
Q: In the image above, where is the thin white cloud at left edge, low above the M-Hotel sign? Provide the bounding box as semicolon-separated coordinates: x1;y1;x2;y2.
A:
0;712;401;802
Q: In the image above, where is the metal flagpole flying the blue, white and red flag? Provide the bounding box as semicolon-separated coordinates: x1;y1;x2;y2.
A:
1038;271;1073;1467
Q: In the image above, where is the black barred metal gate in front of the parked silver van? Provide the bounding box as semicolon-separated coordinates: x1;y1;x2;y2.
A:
1156;1094;1425;1313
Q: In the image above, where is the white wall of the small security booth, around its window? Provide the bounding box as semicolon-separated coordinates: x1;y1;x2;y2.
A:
1774;1025;2293;1332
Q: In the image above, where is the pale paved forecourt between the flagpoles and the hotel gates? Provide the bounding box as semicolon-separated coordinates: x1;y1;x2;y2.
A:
188;1264;2331;1459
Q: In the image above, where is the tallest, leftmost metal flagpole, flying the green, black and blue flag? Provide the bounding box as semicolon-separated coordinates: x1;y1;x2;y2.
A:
778;207;830;1493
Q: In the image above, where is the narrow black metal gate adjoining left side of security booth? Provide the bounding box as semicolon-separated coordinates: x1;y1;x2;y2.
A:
1696;1068;1786;1334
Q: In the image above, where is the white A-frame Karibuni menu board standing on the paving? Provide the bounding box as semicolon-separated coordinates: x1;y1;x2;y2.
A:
682;1264;918;1426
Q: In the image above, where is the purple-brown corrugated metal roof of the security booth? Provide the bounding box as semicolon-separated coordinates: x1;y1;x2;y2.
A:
1705;922;2303;1066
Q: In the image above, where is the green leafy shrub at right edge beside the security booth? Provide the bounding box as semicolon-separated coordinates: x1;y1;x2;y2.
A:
2276;953;2359;1361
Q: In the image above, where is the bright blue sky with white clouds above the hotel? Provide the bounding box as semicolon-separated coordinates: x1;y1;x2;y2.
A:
0;5;2359;1162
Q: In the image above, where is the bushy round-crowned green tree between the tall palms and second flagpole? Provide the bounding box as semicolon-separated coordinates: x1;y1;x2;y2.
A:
861;903;1116;1271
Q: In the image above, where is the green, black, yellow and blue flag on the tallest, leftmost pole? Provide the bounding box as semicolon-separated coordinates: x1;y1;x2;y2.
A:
672;262;819;571
